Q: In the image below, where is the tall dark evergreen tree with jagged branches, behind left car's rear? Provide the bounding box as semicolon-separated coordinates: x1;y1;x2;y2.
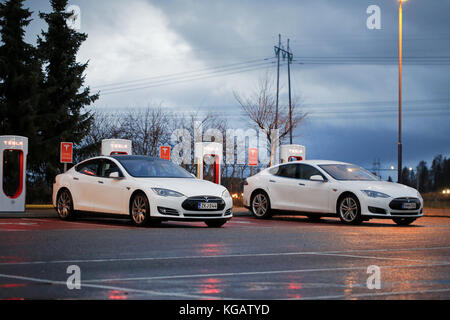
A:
38;0;98;182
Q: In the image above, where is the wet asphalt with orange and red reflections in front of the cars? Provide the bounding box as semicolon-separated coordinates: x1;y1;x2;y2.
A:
0;210;450;300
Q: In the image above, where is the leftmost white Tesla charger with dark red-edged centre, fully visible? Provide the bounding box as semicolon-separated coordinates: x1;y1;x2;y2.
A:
0;136;28;212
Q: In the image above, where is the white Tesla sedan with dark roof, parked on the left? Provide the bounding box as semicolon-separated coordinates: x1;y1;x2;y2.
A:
53;155;233;227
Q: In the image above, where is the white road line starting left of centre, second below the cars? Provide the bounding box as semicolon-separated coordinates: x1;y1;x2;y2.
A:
83;262;450;282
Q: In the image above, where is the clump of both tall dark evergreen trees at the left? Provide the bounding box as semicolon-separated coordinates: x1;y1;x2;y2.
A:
0;0;99;200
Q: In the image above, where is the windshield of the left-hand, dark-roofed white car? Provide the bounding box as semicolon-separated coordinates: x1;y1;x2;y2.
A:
115;156;193;178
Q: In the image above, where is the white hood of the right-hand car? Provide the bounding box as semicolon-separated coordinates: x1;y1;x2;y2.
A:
339;181;417;198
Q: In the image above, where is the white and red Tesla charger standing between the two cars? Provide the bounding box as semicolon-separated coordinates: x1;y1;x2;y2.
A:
194;142;223;184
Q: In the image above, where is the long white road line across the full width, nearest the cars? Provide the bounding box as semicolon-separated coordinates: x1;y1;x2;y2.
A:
0;247;450;266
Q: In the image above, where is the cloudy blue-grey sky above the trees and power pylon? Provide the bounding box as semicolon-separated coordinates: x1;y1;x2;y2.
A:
26;0;450;177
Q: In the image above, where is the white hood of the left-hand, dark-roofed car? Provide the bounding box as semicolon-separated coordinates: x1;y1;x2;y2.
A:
135;178;225;197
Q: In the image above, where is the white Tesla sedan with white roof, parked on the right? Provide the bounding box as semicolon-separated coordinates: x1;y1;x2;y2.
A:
244;160;423;225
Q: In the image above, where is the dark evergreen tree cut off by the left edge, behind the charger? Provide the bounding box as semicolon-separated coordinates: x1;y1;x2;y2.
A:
0;0;42;141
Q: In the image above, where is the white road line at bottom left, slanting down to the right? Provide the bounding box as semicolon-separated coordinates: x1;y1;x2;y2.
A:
0;273;237;300
